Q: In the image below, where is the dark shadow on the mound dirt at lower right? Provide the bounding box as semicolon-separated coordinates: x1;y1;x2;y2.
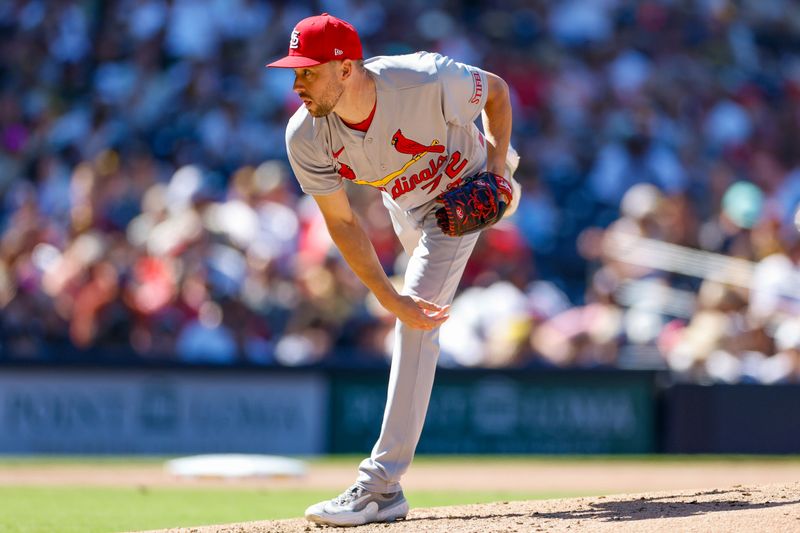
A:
533;489;800;521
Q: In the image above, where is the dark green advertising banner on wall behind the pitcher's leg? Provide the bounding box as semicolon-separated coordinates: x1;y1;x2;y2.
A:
331;371;656;453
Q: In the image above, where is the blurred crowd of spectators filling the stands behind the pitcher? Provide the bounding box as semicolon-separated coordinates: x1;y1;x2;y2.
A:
0;0;800;383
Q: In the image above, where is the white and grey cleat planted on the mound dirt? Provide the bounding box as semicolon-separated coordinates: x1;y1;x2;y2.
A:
306;485;408;527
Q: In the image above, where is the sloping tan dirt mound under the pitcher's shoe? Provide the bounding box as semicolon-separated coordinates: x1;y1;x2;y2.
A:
139;483;800;533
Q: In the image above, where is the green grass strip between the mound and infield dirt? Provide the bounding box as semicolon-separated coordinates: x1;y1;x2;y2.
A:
0;487;578;533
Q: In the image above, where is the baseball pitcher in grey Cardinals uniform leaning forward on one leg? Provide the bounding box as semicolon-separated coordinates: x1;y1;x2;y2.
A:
267;13;521;526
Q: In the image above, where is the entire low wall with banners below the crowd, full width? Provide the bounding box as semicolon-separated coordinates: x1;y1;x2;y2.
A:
0;365;800;455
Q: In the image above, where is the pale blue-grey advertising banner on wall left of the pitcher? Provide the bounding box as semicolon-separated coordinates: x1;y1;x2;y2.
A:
0;369;328;454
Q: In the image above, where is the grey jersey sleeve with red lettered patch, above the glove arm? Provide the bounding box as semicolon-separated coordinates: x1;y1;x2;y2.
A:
435;54;489;126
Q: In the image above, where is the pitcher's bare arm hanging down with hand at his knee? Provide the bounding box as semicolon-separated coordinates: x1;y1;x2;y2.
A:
314;189;449;330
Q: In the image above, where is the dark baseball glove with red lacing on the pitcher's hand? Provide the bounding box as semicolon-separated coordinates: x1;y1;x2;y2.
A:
436;171;513;237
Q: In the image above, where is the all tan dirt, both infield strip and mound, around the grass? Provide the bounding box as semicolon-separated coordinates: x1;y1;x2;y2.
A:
0;458;800;533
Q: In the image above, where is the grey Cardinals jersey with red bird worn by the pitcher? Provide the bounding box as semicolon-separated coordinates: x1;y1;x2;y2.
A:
286;52;487;211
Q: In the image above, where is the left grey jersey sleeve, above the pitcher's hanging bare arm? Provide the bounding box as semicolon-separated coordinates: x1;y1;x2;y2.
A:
286;111;343;195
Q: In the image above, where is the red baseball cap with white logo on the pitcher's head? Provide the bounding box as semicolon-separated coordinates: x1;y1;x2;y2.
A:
267;13;364;68
